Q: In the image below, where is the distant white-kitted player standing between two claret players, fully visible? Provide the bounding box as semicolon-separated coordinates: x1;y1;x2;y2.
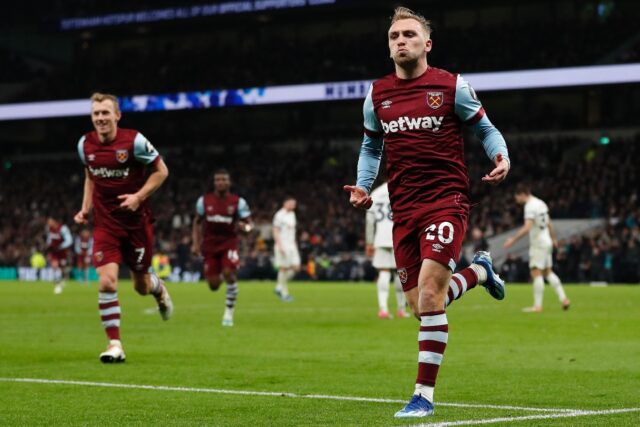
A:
273;197;300;302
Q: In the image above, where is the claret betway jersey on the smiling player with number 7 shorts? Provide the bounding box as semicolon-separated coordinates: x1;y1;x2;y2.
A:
78;129;160;230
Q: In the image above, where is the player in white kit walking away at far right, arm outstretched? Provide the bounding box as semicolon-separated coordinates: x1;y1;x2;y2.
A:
504;184;570;313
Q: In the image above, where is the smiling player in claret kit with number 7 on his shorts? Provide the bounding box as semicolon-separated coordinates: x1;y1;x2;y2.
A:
74;93;173;363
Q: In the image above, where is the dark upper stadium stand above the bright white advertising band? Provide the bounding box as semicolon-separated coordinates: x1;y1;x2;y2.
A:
0;0;637;102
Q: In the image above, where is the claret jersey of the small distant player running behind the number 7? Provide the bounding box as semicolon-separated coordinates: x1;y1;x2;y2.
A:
196;192;251;256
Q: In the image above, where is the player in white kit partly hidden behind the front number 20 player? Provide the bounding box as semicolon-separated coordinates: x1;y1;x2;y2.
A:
366;182;409;319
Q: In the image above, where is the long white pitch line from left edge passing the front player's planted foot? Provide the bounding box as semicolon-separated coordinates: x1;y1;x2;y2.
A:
0;378;578;413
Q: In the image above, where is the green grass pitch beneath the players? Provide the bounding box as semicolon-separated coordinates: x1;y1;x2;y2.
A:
0;281;640;426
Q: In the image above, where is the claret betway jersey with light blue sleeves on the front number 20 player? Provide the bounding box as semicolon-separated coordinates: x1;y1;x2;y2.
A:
364;67;484;222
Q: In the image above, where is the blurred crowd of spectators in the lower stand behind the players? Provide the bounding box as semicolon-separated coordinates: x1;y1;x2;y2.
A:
0;137;640;282
